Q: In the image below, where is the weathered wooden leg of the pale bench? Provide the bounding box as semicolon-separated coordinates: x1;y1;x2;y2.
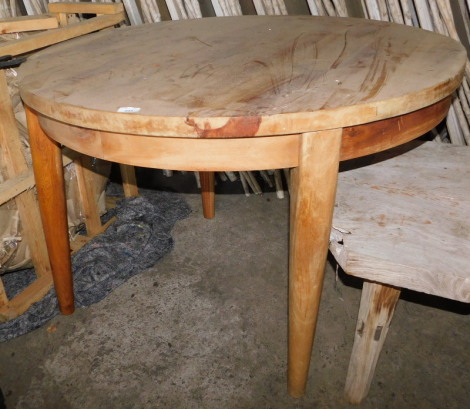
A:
345;281;401;403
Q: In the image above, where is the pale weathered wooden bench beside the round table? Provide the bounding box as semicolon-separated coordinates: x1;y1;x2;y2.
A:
330;142;470;403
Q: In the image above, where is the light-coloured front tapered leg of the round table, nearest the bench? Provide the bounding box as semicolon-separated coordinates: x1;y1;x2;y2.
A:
288;129;342;397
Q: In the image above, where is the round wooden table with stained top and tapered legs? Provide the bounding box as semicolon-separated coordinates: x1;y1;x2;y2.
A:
20;16;466;396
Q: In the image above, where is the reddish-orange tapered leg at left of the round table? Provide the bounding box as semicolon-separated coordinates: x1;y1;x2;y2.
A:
25;107;75;314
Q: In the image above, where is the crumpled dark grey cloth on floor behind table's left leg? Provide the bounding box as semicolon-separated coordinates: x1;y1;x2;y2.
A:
0;190;191;342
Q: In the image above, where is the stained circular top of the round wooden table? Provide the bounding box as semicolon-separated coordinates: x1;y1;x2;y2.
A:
20;16;466;138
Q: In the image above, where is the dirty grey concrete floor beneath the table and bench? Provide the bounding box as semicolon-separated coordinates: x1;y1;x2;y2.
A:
0;190;470;409
